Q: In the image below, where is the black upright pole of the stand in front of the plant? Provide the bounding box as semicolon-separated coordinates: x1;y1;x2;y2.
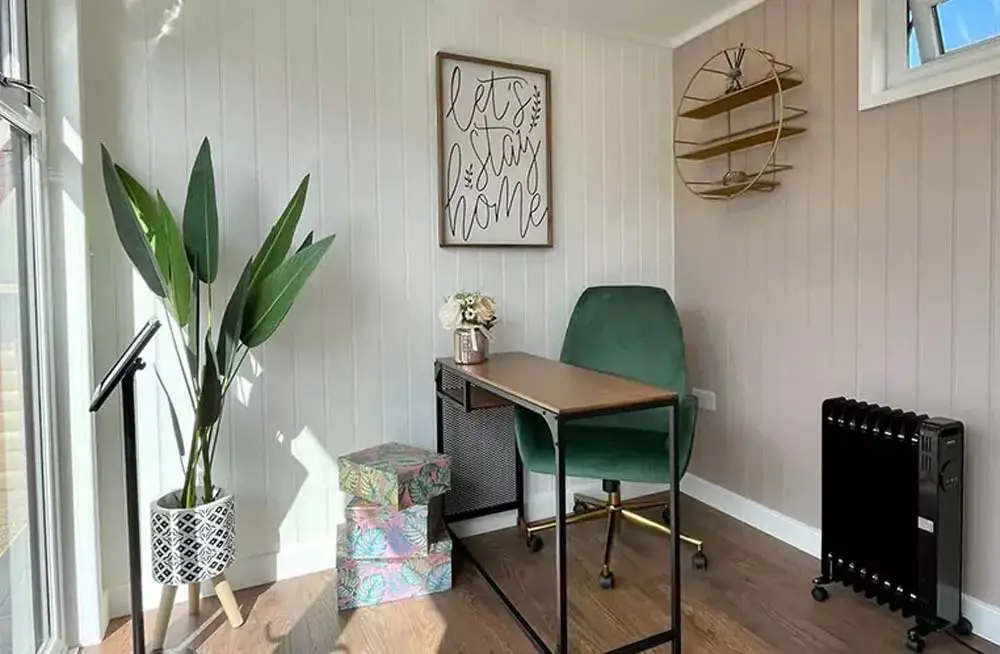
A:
122;359;146;654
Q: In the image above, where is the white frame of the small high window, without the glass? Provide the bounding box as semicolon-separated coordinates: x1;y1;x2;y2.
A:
858;0;1000;110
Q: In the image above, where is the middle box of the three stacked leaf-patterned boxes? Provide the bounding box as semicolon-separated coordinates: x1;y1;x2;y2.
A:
344;497;451;559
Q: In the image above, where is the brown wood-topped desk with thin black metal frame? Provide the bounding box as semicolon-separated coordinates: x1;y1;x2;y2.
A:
434;352;681;654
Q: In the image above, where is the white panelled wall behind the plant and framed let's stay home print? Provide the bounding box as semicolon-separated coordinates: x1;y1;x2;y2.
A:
82;0;674;615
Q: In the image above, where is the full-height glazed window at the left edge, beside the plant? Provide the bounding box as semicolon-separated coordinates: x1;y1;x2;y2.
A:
0;0;56;654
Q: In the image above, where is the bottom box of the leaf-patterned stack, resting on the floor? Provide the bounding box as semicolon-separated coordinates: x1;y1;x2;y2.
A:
337;525;452;611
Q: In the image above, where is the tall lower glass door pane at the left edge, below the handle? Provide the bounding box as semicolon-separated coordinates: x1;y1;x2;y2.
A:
0;119;48;654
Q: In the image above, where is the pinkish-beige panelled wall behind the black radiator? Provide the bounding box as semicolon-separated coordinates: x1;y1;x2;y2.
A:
674;0;1000;604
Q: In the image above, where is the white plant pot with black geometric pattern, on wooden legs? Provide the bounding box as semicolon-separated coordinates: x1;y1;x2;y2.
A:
150;490;236;586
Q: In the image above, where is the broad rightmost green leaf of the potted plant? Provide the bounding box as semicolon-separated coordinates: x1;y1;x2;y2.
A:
240;236;334;347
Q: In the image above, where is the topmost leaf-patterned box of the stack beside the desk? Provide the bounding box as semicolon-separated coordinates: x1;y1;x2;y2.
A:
337;443;451;511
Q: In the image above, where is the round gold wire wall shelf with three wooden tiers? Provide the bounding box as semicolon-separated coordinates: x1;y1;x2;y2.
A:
674;45;808;200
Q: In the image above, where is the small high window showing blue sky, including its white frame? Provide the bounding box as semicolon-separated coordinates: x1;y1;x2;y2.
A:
859;0;1000;109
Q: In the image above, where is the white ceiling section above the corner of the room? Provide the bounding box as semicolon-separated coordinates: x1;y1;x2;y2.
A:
453;0;760;46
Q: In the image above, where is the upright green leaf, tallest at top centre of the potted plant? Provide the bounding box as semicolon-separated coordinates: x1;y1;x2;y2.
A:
184;138;219;284
